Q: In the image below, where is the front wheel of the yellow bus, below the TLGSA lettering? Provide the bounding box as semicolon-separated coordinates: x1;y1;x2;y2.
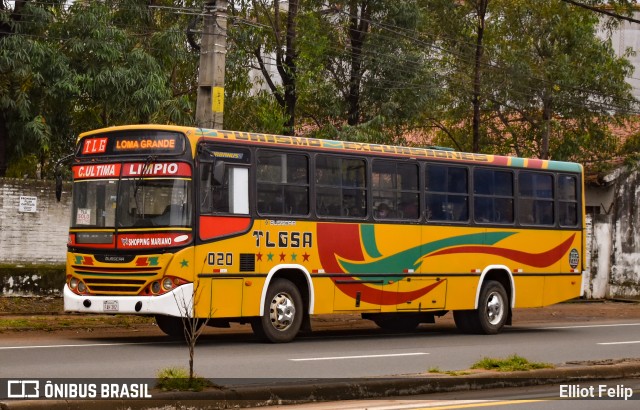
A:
251;279;304;343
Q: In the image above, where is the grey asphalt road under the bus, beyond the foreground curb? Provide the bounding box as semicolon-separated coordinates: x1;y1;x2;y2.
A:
0;320;640;384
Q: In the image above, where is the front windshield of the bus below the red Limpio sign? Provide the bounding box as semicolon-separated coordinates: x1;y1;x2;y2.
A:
71;178;191;228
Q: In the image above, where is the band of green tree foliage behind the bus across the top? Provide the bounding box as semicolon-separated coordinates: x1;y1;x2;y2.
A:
0;0;637;177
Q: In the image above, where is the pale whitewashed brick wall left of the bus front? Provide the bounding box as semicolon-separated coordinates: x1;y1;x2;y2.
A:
0;178;71;265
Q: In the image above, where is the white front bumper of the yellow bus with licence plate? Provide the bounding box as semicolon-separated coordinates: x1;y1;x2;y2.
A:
63;283;193;317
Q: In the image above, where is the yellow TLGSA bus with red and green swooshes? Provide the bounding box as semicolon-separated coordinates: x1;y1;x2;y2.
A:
64;125;585;342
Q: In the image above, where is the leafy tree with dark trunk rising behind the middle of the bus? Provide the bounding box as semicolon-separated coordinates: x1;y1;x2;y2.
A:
300;0;441;143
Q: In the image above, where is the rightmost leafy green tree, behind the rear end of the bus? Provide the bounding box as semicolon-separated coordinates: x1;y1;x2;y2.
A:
487;0;634;161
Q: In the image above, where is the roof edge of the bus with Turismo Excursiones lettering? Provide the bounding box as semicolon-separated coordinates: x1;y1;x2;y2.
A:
78;124;583;173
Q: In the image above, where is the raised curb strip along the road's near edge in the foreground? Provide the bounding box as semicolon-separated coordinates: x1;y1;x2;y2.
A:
0;359;640;410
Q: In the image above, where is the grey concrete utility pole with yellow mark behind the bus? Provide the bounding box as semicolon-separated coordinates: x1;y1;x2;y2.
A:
196;0;227;129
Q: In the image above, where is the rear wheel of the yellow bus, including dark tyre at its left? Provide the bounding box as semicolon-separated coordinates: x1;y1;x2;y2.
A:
453;280;509;335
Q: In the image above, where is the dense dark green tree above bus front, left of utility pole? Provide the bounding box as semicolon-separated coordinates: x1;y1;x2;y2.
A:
65;2;171;129
